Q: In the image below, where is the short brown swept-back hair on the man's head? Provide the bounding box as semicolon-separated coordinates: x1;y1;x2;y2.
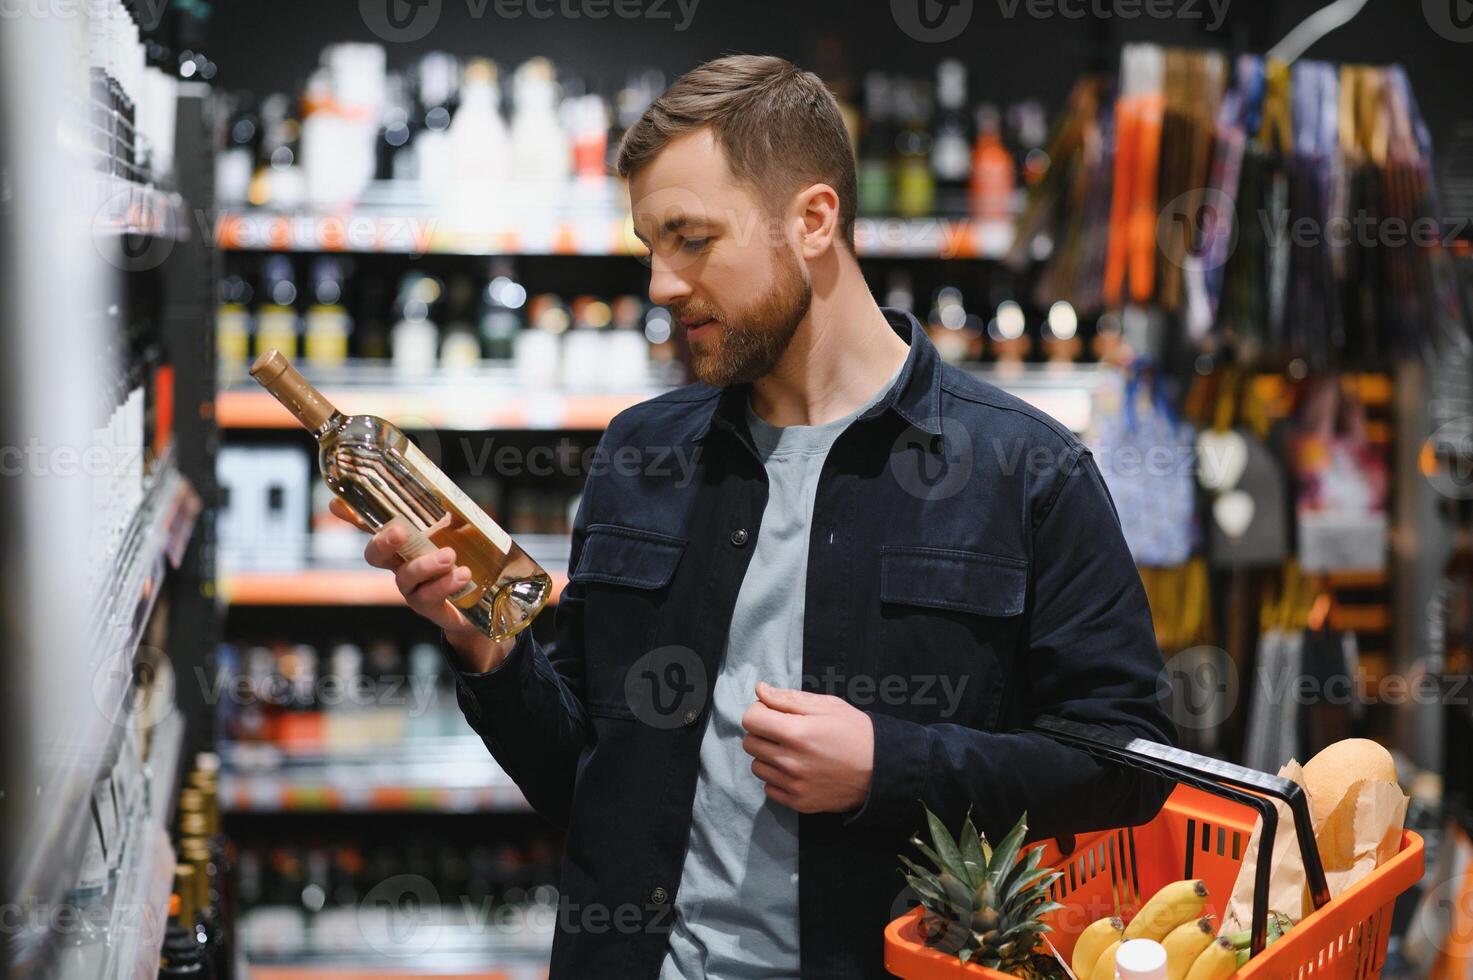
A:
619;55;859;252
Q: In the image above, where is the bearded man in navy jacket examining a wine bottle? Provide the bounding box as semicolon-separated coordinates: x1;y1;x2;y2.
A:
340;56;1174;980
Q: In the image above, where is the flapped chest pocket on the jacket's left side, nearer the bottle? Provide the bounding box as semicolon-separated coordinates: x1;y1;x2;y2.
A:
569;525;686;719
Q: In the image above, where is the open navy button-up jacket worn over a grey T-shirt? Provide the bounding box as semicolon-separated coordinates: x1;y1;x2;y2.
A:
457;309;1175;980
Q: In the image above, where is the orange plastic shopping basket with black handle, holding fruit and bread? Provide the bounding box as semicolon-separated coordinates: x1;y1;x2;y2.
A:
885;718;1421;980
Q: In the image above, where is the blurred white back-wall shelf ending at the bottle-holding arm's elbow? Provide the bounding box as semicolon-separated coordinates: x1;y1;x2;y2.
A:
219;733;530;813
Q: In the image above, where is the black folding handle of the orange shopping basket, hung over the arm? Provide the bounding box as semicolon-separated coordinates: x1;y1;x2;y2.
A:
1034;716;1330;955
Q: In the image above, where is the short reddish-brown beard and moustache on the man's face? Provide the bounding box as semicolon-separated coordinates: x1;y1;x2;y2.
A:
673;249;813;388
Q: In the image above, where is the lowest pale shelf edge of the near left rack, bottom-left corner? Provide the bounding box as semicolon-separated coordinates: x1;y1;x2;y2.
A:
56;712;184;980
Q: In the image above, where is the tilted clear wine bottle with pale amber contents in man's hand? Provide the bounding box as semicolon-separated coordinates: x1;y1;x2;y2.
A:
250;349;552;640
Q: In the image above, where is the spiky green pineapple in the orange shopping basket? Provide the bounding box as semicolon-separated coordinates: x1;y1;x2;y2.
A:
900;805;1064;980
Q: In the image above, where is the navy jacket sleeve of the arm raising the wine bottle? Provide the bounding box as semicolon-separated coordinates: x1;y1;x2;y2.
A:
451;477;597;827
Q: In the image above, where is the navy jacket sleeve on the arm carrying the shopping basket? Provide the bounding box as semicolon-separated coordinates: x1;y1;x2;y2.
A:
846;447;1175;840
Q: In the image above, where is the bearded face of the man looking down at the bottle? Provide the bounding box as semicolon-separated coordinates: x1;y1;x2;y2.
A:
629;130;813;388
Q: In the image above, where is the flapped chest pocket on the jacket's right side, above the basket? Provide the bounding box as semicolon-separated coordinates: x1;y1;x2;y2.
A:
876;545;1028;729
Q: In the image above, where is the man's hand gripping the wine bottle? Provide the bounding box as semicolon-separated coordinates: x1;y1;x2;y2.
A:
330;497;516;673
